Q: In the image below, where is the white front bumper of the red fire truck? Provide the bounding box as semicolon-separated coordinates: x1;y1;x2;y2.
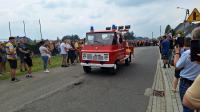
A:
81;63;116;68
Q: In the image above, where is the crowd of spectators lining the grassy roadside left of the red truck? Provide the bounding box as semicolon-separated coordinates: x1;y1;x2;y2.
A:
0;37;83;81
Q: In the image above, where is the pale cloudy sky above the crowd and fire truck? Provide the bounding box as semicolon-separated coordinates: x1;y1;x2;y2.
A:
0;0;200;40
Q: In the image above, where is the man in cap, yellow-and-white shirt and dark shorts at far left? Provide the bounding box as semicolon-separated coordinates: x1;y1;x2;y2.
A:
6;37;19;82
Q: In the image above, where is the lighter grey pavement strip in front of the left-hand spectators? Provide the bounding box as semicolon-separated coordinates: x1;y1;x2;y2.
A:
0;65;84;112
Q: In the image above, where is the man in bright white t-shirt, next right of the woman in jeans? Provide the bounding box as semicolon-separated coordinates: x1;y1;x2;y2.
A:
60;40;68;67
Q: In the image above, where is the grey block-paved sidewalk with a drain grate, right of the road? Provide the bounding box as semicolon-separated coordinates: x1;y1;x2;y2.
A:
146;60;183;112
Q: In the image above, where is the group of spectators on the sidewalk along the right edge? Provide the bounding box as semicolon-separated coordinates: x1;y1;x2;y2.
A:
160;27;200;112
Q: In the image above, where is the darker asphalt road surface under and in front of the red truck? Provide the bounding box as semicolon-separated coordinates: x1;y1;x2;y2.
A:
17;47;159;112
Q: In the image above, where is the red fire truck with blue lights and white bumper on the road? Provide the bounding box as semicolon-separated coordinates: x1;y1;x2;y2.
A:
80;25;132;74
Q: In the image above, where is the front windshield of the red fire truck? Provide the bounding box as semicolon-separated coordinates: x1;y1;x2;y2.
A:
85;33;114;45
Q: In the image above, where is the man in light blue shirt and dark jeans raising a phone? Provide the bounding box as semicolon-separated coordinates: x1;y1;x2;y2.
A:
175;27;200;112
